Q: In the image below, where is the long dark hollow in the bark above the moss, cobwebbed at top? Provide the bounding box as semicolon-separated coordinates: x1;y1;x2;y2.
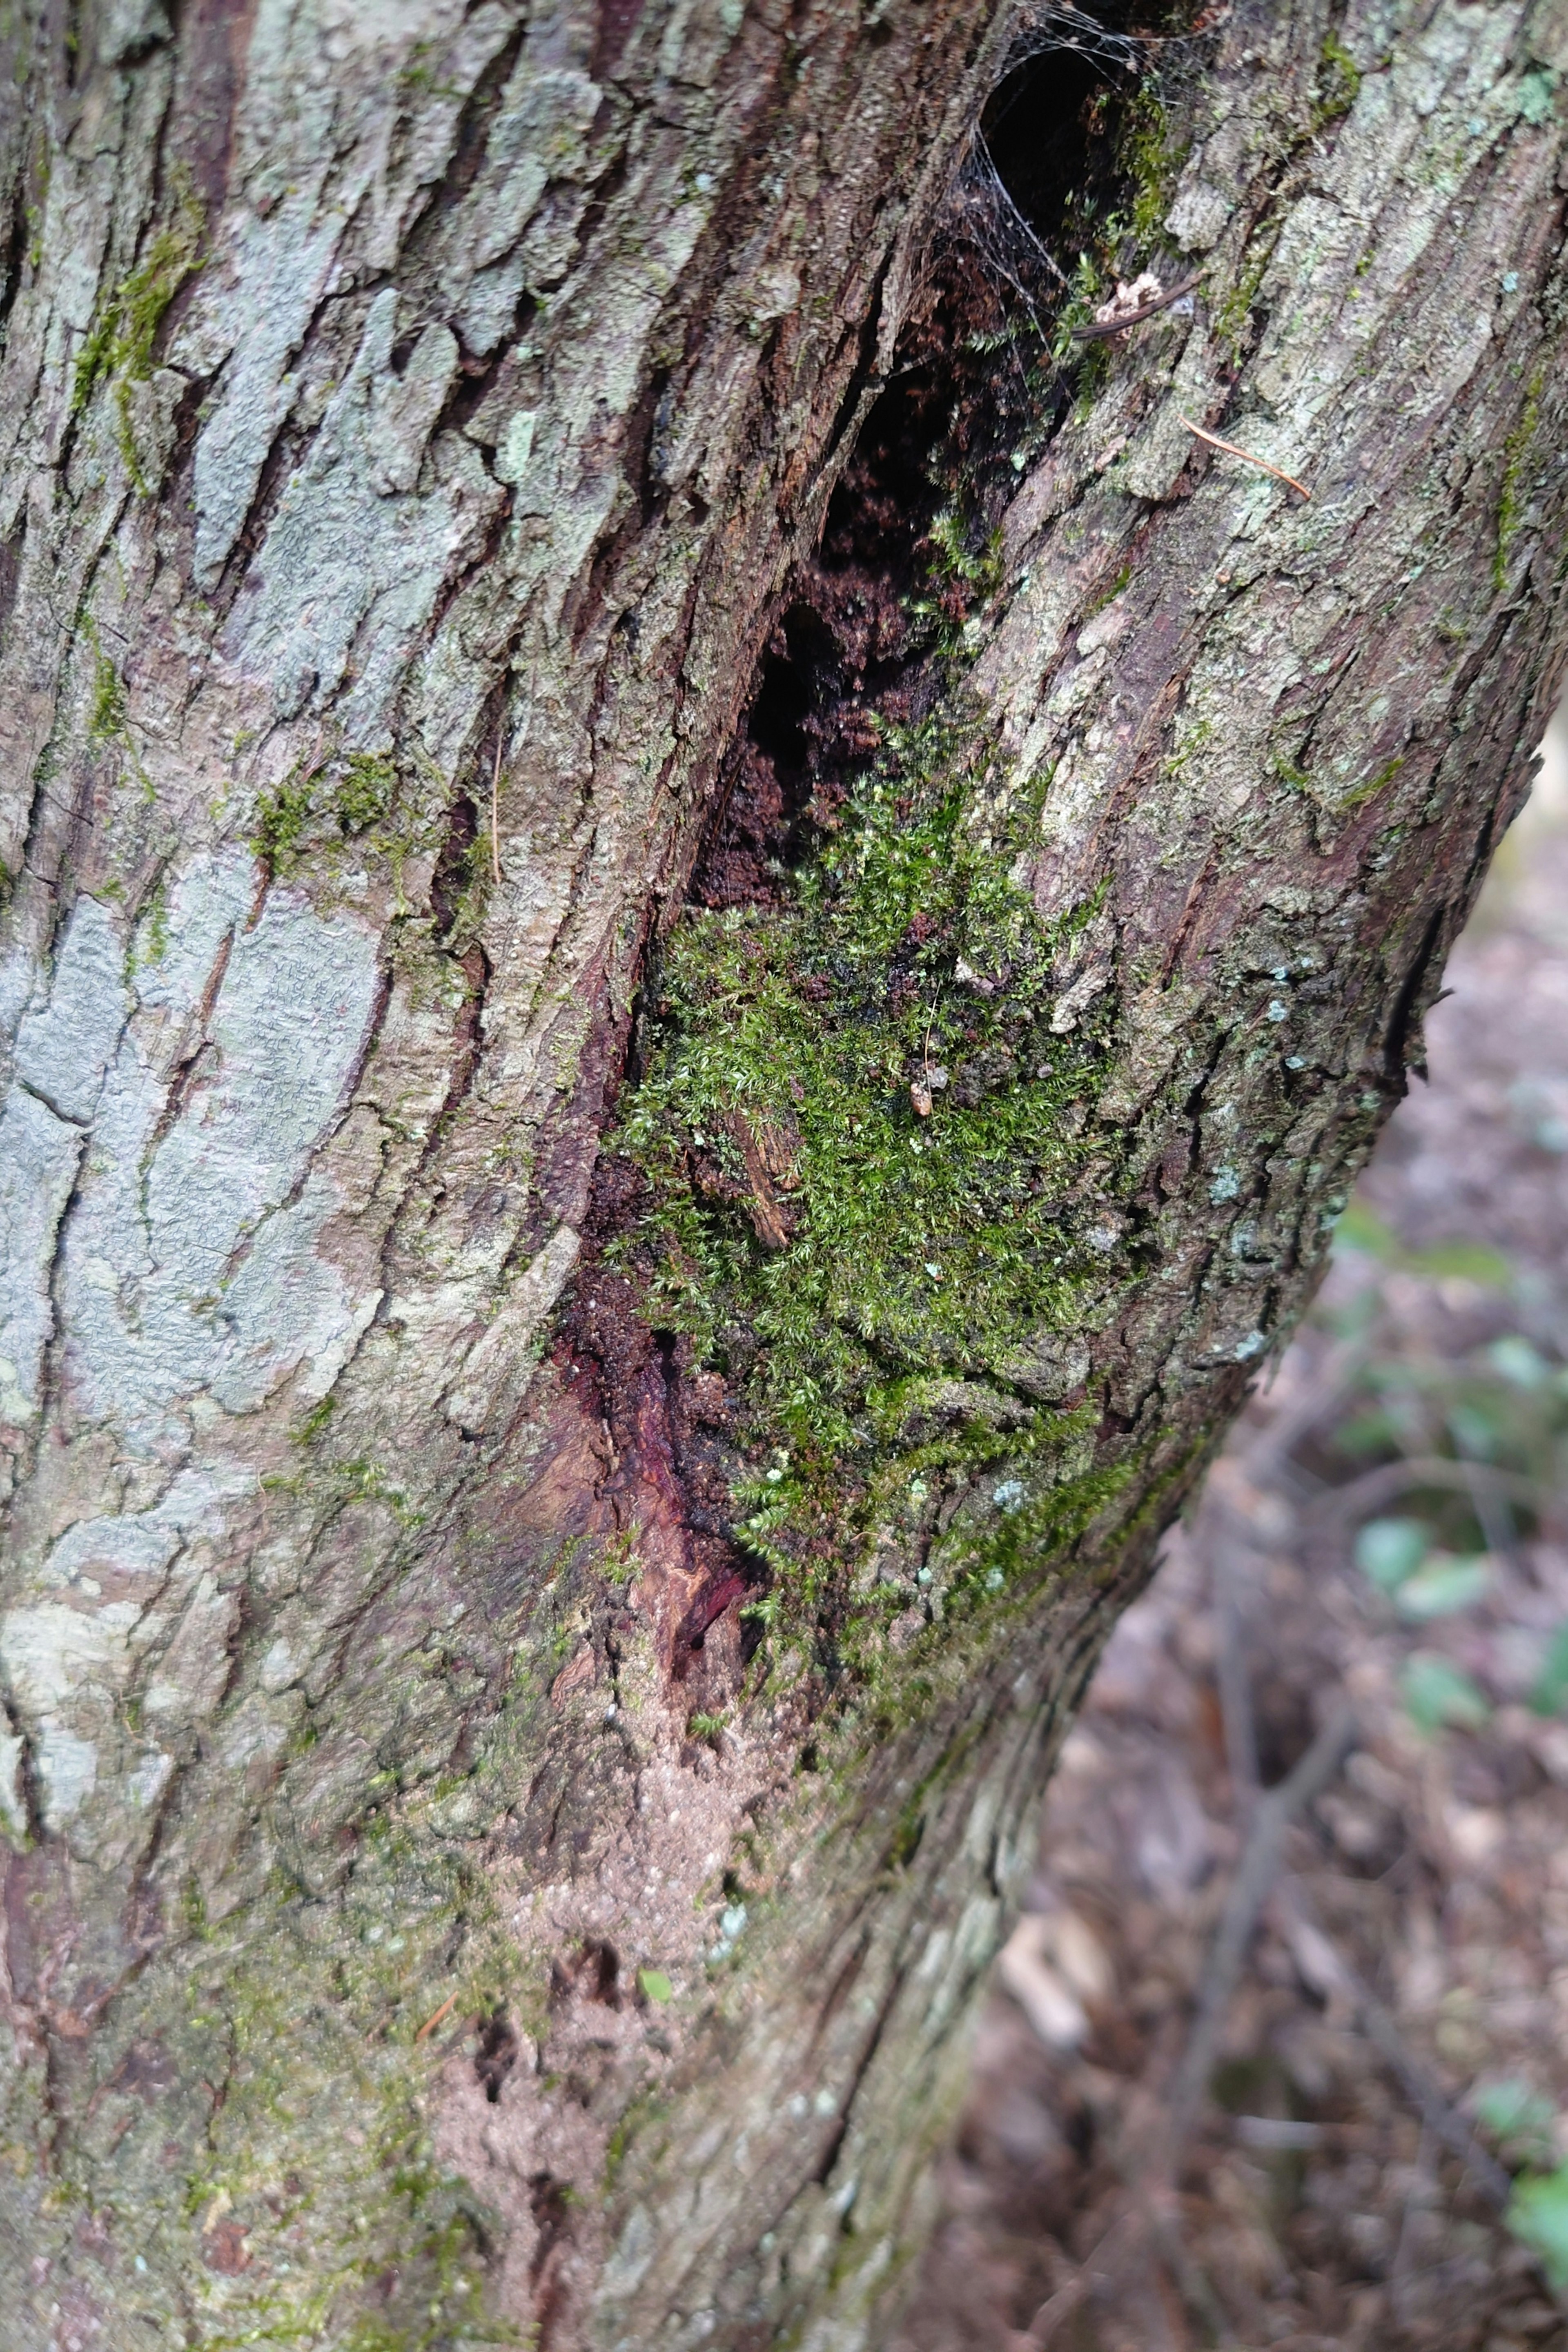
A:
689;7;1166;908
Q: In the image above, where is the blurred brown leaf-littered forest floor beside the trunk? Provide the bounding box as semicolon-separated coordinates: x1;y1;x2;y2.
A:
891;715;1568;2352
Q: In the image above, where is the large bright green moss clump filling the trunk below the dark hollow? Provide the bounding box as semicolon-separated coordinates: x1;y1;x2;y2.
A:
609;696;1121;1656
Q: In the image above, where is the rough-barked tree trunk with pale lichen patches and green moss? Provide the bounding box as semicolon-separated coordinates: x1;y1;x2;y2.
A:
0;0;1568;2352
